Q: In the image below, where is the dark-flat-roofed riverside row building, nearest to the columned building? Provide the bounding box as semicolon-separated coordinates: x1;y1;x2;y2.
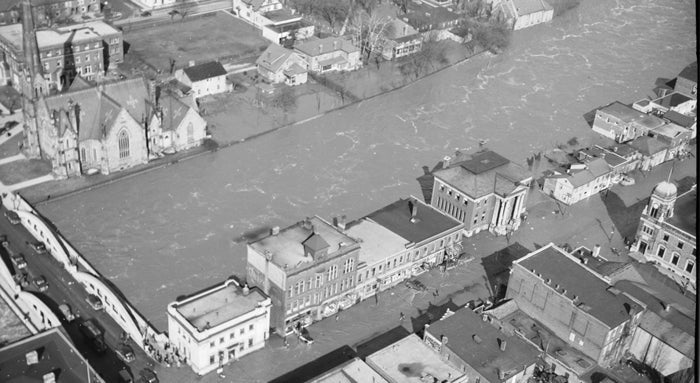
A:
366;197;464;278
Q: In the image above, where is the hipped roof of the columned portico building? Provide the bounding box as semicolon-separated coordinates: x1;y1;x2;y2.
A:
433;150;531;199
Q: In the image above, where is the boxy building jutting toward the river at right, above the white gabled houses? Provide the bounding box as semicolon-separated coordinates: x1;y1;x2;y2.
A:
593;101;664;143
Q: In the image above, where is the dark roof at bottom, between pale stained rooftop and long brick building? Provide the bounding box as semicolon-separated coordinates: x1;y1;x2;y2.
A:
426;308;539;382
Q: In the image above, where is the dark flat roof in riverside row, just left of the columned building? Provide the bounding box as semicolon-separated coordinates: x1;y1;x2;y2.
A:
367;197;462;243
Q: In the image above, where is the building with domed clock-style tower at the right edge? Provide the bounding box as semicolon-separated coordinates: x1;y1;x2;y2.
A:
631;181;698;290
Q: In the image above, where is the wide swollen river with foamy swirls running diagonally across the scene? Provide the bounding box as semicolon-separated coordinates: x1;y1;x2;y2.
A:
40;0;697;330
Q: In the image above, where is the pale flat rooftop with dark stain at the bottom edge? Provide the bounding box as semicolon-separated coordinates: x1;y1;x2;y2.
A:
365;334;463;383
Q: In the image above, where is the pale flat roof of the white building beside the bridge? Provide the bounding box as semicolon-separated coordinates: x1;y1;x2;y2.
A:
173;282;267;331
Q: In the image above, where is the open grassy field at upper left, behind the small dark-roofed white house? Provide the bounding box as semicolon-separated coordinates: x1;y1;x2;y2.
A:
124;12;269;73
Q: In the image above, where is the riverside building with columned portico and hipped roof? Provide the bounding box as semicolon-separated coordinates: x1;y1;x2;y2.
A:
430;150;532;237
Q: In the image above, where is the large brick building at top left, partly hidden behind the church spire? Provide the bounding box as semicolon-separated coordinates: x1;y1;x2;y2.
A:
0;21;124;91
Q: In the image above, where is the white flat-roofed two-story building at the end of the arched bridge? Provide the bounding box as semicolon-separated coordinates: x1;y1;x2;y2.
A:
168;280;272;375
